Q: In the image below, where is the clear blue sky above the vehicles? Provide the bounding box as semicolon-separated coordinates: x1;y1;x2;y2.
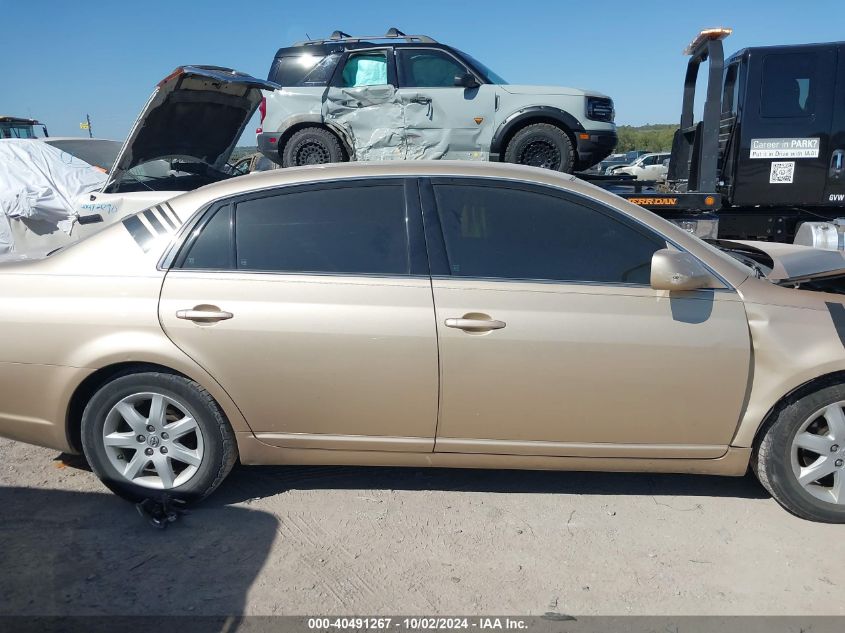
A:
0;0;845;145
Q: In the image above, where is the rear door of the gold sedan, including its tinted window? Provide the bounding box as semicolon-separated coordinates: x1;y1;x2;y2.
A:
159;179;438;451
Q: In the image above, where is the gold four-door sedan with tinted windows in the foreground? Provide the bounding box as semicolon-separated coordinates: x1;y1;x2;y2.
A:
0;162;845;522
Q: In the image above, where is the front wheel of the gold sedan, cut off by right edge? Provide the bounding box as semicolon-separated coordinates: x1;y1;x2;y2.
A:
752;385;845;523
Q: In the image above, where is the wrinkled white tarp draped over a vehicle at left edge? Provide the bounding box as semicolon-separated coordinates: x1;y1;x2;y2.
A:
0;139;106;253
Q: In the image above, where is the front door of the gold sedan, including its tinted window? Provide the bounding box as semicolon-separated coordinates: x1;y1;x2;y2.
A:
423;179;750;458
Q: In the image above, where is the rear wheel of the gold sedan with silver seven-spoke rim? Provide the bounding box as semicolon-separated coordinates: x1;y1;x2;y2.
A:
82;372;238;501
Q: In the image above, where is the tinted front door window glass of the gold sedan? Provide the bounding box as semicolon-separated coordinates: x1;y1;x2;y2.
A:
435;184;666;285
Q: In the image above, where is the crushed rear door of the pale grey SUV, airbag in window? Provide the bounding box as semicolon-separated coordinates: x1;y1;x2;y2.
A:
322;47;405;160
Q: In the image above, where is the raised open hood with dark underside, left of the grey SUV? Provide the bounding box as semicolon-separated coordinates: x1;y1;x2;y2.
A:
103;66;279;191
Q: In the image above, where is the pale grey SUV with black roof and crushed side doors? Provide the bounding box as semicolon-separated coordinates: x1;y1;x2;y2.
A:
257;29;617;172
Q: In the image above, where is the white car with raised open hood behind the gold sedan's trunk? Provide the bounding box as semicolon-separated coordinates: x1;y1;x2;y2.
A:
2;66;276;251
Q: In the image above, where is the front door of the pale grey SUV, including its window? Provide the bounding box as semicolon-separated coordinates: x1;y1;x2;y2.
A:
396;47;496;160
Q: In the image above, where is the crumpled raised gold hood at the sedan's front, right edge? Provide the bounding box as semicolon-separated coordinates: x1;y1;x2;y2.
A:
711;240;845;284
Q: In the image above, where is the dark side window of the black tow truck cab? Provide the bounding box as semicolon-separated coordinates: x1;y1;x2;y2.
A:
760;53;818;117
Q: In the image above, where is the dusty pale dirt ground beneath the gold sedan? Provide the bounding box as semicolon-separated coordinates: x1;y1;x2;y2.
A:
0;440;845;615
